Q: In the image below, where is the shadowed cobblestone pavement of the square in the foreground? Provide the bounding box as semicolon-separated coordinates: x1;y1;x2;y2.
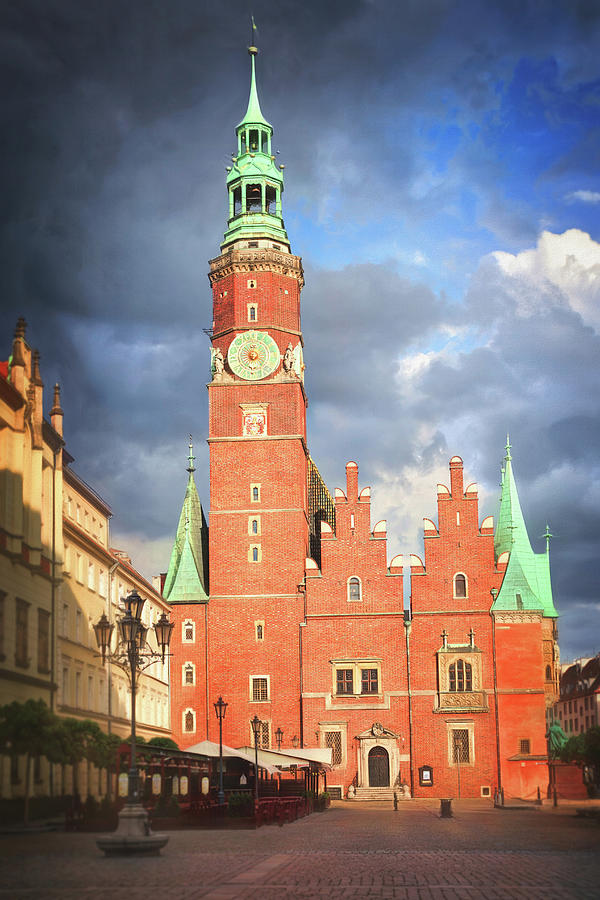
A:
0;801;600;900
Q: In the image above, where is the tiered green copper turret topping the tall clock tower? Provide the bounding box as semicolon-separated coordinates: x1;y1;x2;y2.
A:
221;47;289;250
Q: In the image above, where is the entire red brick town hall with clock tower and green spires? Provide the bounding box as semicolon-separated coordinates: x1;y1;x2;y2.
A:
164;47;558;799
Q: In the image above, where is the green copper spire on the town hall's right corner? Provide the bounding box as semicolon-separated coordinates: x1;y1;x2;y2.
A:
492;438;558;618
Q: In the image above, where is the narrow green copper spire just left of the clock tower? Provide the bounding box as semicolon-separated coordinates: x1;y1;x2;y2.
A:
163;435;208;603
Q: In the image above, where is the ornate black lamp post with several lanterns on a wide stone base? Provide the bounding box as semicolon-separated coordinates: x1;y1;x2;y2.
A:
93;591;175;856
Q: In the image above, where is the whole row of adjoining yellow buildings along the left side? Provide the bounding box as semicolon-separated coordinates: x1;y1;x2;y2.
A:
0;319;175;797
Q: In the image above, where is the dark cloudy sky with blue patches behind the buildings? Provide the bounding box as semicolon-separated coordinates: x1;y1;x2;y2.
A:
0;0;600;659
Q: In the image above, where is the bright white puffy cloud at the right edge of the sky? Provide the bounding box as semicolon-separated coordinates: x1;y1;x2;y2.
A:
492;228;600;333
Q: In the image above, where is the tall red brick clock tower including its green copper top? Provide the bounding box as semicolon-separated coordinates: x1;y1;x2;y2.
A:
207;47;311;746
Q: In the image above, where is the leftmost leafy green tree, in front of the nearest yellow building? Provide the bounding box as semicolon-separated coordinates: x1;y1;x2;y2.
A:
0;700;59;824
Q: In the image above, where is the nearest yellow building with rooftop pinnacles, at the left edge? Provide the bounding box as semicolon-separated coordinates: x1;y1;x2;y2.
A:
0;319;63;796
